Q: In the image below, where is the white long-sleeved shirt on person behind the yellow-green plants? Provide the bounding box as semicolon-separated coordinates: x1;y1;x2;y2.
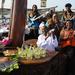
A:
37;34;58;51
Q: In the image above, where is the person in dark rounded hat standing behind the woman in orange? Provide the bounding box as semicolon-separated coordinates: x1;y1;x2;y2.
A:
62;3;74;21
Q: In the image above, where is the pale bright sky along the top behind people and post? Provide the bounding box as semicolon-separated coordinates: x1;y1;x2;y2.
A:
0;0;75;11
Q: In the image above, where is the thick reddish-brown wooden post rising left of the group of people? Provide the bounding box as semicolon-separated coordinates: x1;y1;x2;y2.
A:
9;0;27;46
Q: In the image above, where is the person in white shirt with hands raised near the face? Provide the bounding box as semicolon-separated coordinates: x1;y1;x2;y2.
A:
37;29;58;52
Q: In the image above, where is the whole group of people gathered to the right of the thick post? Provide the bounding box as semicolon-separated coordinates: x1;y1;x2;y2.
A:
27;3;75;51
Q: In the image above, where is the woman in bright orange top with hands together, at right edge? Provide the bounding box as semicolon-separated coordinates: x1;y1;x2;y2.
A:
60;20;74;47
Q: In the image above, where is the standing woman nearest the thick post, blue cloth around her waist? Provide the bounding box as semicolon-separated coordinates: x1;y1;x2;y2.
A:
28;5;40;38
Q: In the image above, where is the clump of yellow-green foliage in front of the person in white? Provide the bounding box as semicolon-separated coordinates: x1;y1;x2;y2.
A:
17;46;47;60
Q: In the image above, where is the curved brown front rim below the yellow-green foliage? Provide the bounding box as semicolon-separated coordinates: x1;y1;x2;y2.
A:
19;52;58;64
